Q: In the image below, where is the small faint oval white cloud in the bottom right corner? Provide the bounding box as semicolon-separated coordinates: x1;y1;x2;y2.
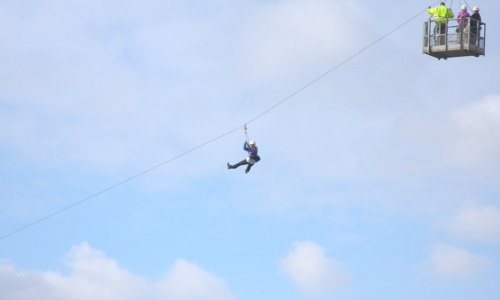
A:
424;243;492;278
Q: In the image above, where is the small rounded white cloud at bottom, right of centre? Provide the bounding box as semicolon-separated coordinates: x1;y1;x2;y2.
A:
280;241;352;296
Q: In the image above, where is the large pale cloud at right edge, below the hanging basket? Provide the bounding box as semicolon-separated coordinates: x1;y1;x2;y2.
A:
367;95;500;179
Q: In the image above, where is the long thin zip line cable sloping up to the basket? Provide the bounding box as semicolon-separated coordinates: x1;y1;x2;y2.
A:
0;2;438;240
